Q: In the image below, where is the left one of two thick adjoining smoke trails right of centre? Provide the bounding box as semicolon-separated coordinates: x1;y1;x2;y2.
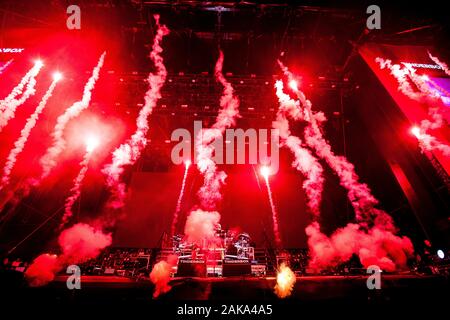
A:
273;81;324;216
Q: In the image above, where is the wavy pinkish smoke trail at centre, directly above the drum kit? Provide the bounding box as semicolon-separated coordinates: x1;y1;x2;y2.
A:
195;51;239;210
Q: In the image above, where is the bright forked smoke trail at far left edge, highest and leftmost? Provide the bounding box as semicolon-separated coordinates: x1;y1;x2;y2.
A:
0;62;43;132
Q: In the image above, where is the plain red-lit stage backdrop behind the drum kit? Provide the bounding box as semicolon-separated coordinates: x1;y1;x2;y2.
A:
114;165;309;247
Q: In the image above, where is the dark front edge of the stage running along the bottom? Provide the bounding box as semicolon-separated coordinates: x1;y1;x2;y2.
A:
2;274;450;306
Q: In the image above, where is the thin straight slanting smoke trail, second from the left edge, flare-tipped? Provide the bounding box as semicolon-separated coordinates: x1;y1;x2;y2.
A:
0;79;58;190
